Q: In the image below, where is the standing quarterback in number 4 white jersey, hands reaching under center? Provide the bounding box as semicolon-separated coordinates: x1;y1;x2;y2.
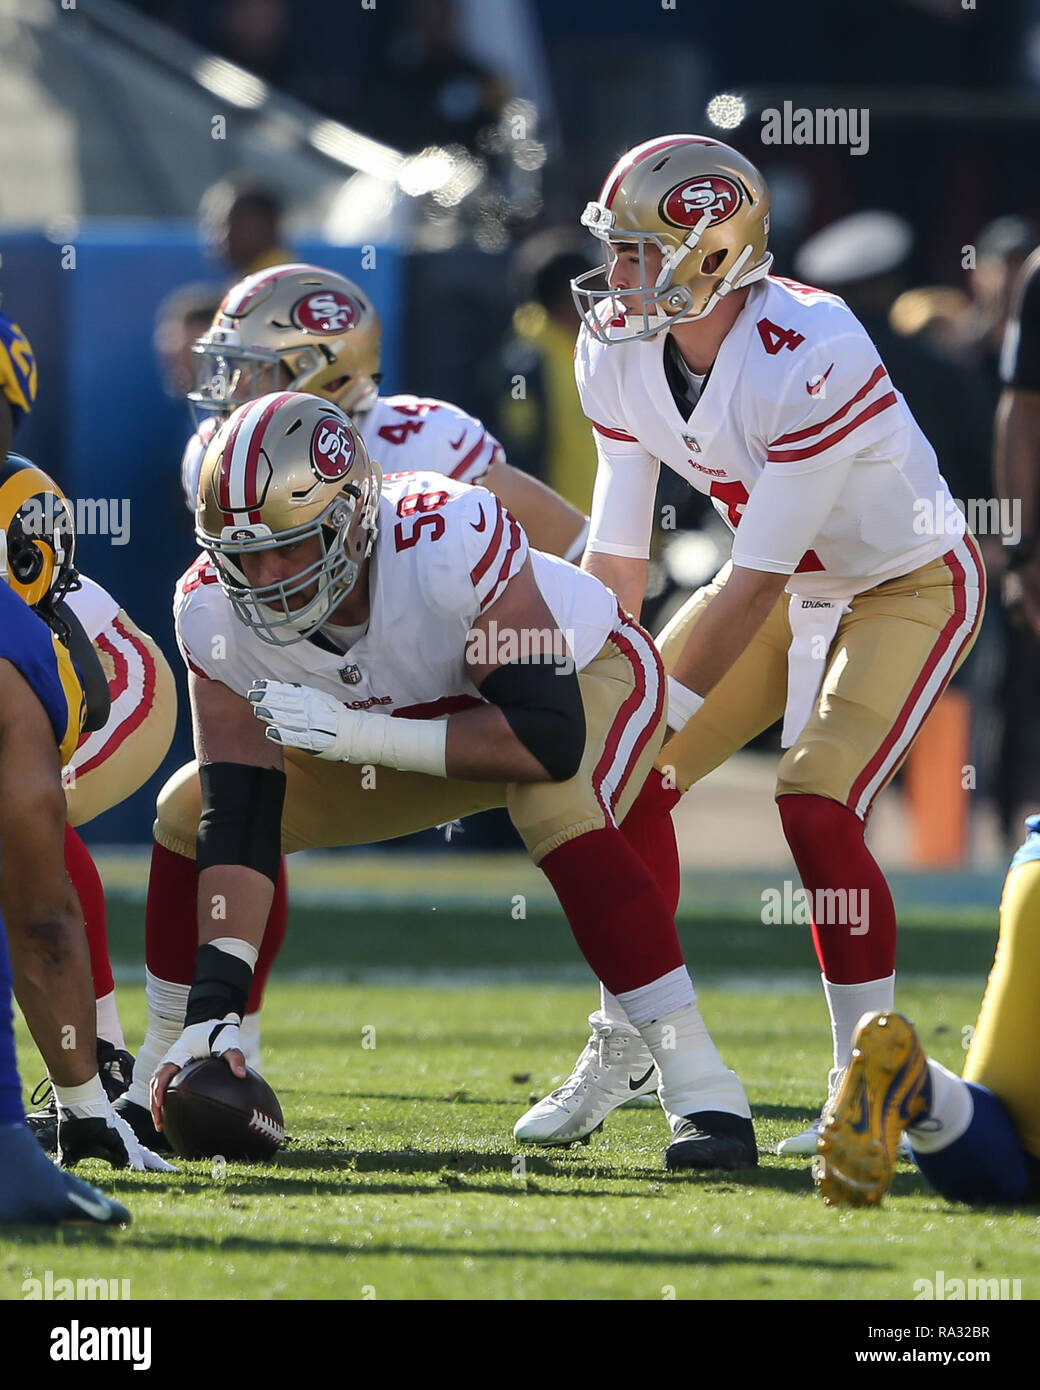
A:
516;135;984;1154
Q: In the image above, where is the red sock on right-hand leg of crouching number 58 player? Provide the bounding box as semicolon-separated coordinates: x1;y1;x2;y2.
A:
541;826;683;994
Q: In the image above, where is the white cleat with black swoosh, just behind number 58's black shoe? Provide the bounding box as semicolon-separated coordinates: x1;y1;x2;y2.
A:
513;1011;659;1144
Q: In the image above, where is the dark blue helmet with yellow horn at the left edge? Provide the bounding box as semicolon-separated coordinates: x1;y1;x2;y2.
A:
0;453;79;614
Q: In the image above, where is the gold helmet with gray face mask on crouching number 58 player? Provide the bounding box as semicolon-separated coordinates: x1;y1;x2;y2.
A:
195;391;382;646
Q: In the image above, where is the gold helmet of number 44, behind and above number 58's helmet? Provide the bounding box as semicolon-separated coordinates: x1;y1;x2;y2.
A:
188;264;382;424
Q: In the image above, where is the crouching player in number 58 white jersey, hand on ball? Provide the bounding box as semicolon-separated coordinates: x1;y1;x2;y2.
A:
132;392;756;1168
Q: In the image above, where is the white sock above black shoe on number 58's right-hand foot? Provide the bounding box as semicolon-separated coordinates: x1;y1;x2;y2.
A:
640;999;751;1127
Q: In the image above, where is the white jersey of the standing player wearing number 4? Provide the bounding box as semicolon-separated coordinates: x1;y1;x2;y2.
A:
574;275;964;598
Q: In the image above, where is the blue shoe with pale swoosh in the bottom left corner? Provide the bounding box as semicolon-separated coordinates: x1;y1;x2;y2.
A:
0;1125;131;1226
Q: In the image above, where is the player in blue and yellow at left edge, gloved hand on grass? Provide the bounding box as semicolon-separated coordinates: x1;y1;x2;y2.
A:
0;456;170;1225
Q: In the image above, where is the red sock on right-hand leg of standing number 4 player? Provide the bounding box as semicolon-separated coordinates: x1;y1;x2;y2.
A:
777;796;895;984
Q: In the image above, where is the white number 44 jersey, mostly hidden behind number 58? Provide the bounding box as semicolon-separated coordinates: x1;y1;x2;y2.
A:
181;396;505;512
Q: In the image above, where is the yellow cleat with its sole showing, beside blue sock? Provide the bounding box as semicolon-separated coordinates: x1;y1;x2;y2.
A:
812;1013;929;1207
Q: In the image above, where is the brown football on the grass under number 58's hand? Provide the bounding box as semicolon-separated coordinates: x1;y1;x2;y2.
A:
163;1056;285;1161
